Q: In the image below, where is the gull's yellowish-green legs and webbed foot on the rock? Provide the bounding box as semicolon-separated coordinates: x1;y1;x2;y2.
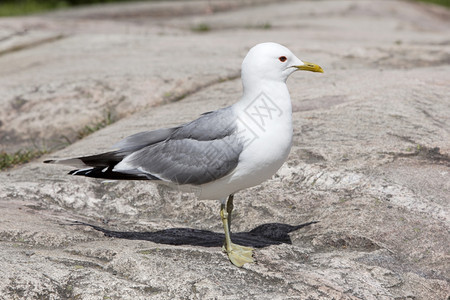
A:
220;195;254;267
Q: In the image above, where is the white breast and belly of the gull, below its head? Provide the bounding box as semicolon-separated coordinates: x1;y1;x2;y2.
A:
199;85;292;199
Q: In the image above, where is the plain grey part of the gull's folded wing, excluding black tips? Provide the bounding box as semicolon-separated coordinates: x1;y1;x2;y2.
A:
115;108;243;185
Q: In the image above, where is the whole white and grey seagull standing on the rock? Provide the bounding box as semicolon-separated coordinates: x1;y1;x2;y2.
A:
44;42;323;267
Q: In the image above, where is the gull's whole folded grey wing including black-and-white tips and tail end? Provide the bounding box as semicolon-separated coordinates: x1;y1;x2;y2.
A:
45;108;243;185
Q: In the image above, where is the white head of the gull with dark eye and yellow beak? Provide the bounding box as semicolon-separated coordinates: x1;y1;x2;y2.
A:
242;43;323;82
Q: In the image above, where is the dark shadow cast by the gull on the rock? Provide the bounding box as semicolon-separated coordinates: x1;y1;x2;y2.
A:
69;221;317;248
